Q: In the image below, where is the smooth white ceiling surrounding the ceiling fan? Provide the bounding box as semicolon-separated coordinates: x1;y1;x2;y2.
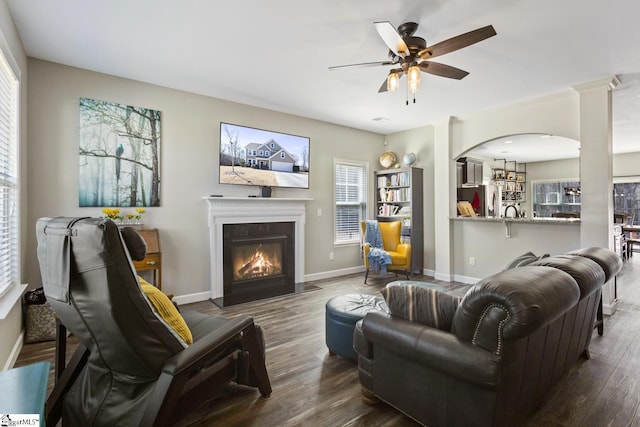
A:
6;0;640;152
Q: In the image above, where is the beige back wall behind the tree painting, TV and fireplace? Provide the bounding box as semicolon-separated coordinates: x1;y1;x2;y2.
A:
27;59;384;296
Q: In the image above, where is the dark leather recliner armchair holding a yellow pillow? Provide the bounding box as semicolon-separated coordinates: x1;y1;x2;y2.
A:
36;218;271;426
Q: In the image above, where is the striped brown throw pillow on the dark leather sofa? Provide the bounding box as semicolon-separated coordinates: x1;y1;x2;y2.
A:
381;284;462;331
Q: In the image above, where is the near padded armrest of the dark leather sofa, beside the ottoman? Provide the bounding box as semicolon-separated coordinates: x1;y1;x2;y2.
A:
356;312;501;388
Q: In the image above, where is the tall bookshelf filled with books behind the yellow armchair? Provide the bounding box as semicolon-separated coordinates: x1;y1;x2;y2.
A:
374;167;424;274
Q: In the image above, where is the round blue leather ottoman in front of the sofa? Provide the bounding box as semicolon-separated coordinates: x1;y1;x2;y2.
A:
325;294;388;360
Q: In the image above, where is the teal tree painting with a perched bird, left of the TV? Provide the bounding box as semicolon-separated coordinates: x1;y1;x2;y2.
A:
79;98;160;207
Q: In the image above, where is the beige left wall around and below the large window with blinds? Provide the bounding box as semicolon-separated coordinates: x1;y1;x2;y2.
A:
0;0;28;369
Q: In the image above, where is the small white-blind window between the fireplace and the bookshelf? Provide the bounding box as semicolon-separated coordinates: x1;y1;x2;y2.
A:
334;160;368;243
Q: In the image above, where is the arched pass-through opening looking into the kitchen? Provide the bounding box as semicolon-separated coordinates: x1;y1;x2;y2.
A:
457;133;580;218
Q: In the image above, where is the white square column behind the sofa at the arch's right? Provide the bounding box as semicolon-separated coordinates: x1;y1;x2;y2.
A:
574;77;618;314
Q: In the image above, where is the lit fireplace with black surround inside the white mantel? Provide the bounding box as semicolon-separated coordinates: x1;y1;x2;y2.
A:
222;222;295;306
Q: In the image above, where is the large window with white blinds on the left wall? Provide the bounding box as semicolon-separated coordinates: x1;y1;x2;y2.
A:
0;50;20;295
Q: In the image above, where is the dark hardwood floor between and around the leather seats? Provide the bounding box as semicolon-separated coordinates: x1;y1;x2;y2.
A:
16;260;640;427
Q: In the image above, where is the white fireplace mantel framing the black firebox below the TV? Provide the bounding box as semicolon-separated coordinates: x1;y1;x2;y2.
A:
203;197;313;299
